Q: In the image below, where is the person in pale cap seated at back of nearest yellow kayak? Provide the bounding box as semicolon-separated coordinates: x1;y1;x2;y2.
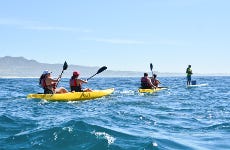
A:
39;70;68;94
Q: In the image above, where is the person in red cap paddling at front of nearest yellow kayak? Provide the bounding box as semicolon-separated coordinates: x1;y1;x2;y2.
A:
69;71;92;92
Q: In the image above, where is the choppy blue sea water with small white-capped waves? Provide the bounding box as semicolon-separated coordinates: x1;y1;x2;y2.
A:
0;76;230;150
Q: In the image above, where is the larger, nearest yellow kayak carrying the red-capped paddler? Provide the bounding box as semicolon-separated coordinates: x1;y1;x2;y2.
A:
27;88;114;101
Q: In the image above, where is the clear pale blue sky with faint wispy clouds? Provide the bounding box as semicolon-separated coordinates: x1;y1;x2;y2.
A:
0;0;230;73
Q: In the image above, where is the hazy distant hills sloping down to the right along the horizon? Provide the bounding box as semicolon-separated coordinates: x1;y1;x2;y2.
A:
0;56;143;78
